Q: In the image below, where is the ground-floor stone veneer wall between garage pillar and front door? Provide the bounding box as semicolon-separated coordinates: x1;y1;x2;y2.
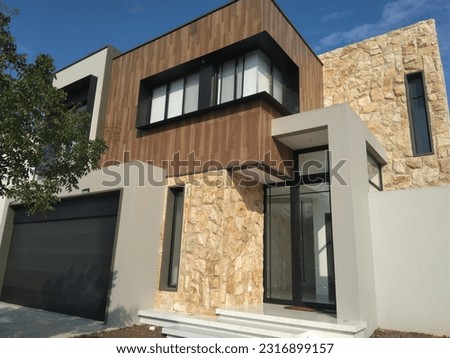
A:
155;170;264;315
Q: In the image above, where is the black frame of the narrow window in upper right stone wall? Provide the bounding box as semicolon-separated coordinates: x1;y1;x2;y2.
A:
405;71;434;157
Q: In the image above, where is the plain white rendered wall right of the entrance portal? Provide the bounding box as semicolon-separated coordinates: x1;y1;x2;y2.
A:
369;186;450;335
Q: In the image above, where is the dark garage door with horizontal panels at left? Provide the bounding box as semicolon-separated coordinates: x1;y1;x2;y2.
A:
0;192;120;321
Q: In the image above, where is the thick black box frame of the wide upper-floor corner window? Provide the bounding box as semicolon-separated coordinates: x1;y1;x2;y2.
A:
135;32;300;131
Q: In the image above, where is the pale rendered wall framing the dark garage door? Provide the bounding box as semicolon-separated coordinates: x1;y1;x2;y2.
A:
0;162;166;327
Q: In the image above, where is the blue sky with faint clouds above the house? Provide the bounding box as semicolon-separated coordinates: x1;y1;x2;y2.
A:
0;0;450;92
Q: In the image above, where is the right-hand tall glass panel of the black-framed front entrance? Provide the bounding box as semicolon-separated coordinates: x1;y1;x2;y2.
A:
299;192;335;304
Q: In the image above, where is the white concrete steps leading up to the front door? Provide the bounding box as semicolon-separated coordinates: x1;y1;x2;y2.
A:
139;305;366;338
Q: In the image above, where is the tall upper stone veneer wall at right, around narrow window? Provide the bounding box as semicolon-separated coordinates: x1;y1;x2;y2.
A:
319;20;450;189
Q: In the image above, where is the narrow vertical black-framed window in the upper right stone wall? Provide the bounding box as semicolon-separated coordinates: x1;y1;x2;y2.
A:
406;72;433;156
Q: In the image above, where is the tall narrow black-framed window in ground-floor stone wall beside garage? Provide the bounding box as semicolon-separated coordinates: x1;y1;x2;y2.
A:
159;187;184;291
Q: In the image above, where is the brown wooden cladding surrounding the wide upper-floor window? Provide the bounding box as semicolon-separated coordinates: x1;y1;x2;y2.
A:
102;0;323;174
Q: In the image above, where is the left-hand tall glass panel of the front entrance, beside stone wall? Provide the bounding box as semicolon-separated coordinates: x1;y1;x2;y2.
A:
265;187;293;300
